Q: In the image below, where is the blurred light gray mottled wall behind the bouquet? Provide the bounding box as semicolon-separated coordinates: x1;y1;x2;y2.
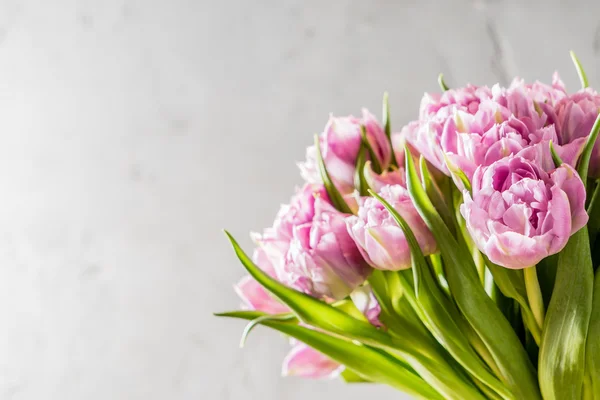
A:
0;0;600;400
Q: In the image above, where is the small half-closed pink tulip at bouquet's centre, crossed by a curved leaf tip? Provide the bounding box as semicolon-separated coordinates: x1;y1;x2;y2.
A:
346;185;436;271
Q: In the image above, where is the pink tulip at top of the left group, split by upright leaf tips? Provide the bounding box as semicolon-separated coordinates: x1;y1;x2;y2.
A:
298;109;392;188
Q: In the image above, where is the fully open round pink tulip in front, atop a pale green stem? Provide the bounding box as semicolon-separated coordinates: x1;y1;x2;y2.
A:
460;156;588;269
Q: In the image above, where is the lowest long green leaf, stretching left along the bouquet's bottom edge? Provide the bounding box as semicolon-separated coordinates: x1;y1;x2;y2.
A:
216;313;443;400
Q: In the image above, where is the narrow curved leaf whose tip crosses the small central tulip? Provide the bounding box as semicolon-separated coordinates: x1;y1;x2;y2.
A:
370;191;513;399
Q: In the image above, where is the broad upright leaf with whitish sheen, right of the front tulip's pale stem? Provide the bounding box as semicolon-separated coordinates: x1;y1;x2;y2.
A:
538;227;597;400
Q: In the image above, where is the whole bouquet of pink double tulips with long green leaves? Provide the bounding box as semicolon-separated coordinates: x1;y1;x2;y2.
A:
217;54;600;400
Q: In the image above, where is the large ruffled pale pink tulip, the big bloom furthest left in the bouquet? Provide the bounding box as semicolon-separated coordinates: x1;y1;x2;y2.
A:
250;184;371;299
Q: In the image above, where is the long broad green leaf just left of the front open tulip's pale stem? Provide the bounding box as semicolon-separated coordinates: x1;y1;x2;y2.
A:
405;148;541;400
